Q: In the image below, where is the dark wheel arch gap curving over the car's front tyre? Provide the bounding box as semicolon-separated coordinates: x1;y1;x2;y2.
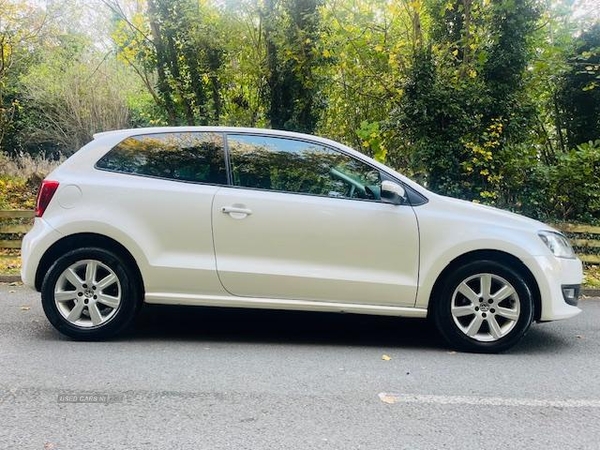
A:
428;250;542;320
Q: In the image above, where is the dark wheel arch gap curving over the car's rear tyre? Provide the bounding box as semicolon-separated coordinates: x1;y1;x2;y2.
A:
35;233;145;298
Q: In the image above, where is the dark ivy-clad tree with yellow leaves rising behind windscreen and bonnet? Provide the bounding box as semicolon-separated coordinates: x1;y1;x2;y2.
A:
388;0;537;200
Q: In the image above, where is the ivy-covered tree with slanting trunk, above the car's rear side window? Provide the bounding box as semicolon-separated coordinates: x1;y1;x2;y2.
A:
104;0;224;125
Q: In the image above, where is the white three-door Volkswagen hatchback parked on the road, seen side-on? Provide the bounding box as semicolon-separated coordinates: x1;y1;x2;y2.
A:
22;127;582;352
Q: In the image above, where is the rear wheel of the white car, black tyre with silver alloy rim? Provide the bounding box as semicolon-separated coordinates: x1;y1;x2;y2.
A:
42;247;141;340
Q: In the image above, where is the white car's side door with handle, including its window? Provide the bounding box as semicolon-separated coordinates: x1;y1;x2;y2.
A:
212;134;419;306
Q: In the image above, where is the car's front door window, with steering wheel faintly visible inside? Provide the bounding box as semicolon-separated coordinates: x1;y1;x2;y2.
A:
227;135;381;200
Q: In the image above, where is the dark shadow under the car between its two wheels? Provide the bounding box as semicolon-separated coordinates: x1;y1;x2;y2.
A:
126;305;447;350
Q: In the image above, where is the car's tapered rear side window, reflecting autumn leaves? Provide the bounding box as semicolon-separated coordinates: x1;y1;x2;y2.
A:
96;132;227;184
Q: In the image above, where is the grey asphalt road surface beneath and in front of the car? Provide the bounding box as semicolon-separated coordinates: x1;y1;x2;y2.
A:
0;284;600;450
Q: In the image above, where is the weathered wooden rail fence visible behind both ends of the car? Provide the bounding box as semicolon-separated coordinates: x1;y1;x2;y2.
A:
0;210;600;264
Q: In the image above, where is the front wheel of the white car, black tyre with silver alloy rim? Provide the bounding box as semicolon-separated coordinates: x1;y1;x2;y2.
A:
433;260;533;353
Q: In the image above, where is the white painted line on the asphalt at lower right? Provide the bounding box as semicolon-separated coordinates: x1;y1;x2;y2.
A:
379;392;600;408
